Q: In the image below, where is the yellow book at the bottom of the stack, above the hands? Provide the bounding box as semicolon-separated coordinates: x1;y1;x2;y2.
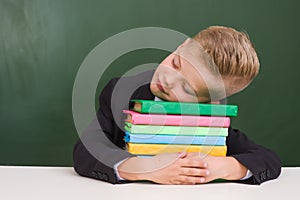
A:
127;142;227;156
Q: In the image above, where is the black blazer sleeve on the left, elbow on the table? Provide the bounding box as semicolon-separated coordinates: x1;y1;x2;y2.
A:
73;79;133;184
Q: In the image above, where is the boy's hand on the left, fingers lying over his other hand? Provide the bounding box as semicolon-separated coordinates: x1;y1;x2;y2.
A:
118;152;209;184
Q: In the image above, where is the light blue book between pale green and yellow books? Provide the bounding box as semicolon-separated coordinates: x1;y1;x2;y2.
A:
124;132;226;146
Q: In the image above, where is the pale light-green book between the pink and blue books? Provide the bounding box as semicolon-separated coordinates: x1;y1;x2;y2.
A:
125;122;228;137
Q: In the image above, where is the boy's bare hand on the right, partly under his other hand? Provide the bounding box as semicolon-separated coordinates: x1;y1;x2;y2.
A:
187;153;247;183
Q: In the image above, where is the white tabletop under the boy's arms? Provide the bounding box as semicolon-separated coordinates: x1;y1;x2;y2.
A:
0;166;300;200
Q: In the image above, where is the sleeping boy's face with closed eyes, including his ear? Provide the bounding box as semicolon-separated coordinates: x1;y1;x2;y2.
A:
150;38;250;102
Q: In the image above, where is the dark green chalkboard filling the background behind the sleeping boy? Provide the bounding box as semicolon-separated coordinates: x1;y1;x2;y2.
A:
0;0;300;166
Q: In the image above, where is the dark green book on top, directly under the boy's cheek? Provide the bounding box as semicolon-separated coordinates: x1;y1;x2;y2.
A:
131;99;238;117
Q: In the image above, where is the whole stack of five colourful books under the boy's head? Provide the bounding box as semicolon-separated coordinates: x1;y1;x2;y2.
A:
123;100;238;156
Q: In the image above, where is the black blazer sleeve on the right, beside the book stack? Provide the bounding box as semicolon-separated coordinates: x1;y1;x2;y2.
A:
227;127;281;184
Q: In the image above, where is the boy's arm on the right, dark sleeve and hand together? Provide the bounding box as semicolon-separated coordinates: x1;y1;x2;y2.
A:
190;127;281;184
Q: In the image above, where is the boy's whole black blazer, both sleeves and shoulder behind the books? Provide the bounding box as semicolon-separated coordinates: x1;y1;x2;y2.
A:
73;71;281;184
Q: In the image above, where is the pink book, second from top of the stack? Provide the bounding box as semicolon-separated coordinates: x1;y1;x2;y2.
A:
123;110;230;127
